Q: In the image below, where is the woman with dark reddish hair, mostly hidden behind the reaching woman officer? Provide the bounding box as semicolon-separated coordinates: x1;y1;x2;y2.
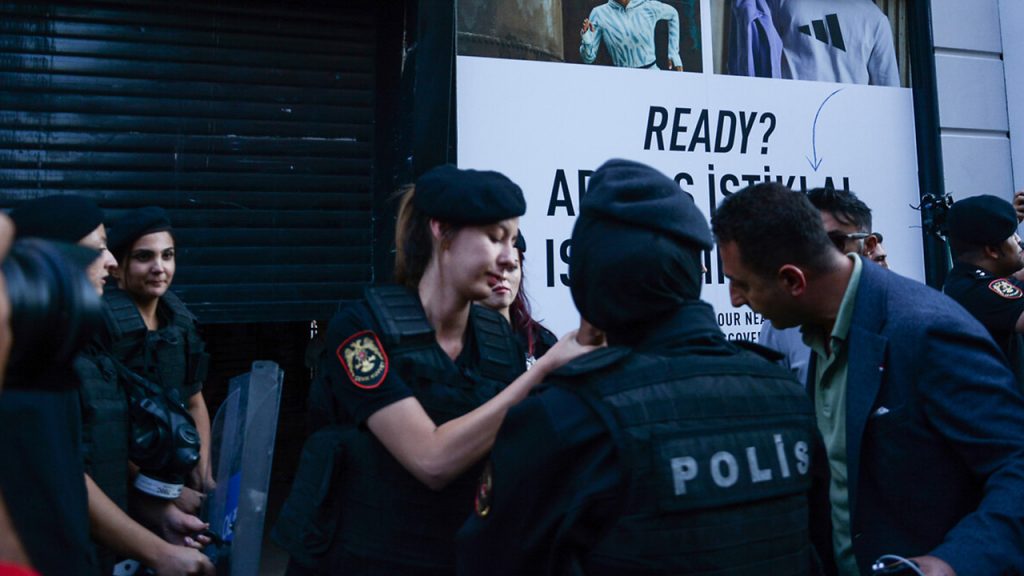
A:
480;231;558;370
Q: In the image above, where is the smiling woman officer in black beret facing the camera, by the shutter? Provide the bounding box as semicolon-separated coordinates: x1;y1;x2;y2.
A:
103;206;213;513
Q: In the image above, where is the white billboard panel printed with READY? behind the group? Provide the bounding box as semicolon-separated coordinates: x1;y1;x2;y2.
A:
456;1;924;340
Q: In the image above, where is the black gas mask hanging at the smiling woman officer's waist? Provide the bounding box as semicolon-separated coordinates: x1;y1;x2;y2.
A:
121;368;200;500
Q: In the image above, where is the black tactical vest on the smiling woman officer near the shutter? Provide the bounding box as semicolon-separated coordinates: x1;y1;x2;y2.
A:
103;289;210;405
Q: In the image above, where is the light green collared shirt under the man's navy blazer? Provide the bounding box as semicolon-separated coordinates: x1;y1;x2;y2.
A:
803;254;863;576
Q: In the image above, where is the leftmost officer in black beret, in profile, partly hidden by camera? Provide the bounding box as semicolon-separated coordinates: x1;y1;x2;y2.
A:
0;196;213;575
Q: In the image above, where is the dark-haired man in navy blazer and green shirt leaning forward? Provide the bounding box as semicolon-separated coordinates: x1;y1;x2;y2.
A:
712;184;1024;576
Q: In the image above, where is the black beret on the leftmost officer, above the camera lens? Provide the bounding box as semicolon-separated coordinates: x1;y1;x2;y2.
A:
10;196;103;244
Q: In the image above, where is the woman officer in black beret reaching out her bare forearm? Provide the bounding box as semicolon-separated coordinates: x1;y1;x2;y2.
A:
284;166;589;575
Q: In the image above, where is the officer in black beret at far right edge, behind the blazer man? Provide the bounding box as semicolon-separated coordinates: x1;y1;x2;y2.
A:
942;196;1024;385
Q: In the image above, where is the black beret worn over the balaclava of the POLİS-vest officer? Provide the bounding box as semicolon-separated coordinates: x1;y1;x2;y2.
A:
581;160;712;250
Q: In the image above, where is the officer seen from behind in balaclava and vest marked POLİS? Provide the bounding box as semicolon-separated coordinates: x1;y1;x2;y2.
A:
458;160;816;576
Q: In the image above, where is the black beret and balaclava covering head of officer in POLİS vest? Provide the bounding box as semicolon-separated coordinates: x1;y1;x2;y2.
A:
569;160;712;336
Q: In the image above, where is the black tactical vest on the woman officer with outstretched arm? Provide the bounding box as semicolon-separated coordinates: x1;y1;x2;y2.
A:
339;286;523;573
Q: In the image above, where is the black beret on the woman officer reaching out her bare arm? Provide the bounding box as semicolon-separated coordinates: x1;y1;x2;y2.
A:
413;164;526;224
